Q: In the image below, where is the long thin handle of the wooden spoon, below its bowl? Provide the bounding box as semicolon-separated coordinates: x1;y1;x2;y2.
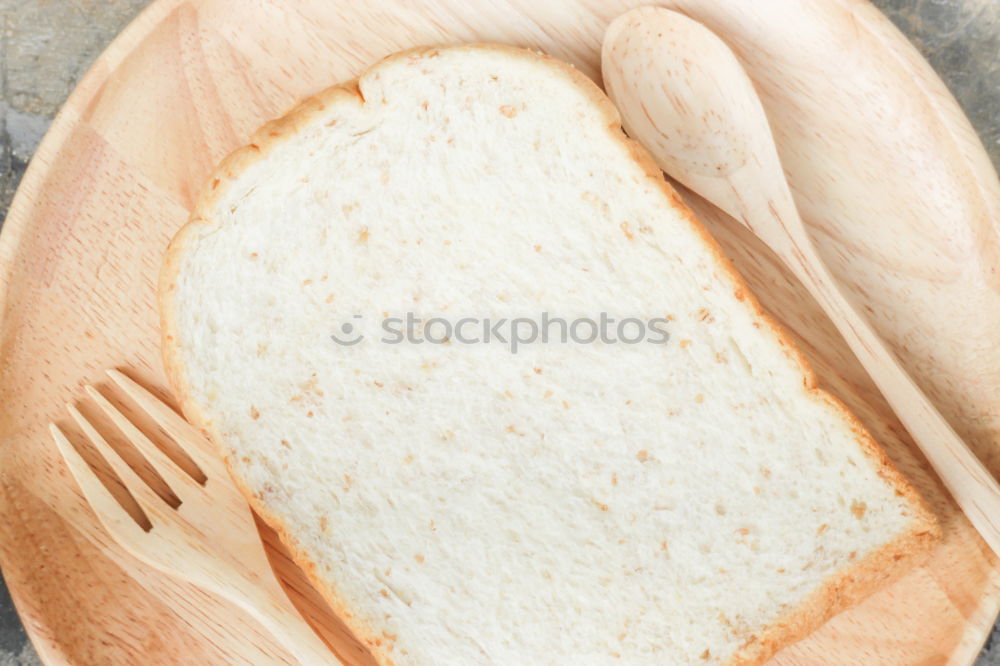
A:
781;220;1000;555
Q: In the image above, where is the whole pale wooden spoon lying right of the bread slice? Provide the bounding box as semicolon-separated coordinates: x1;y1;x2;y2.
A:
601;7;1000;555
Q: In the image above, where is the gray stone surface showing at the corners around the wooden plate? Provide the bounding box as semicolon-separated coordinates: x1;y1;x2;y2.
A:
0;0;1000;666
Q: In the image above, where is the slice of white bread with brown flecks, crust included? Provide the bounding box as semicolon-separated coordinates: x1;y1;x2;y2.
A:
160;45;937;665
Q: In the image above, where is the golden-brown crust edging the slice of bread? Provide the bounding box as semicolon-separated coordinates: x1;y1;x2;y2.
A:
158;43;940;666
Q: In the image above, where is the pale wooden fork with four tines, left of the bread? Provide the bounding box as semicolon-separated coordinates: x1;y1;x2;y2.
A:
50;370;341;666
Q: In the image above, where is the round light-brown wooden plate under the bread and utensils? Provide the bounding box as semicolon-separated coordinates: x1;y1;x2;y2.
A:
0;0;1000;665
